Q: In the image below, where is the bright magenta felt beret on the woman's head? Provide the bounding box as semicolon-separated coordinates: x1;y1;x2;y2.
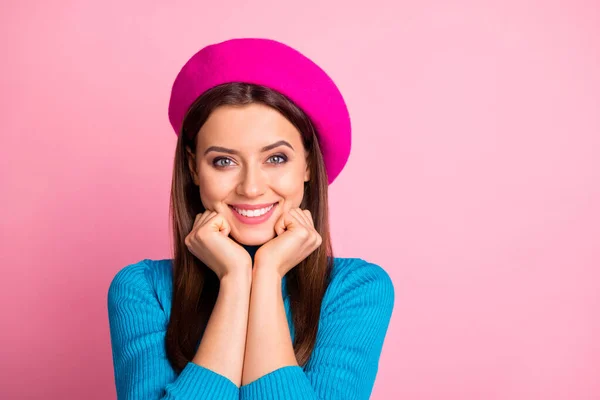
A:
169;38;351;184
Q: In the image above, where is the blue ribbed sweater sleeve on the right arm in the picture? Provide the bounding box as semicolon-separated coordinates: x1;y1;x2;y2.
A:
240;259;394;400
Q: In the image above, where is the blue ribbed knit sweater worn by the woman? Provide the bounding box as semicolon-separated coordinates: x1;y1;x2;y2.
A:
108;258;394;400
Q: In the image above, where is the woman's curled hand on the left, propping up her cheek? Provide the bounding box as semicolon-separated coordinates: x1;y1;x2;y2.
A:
185;210;252;280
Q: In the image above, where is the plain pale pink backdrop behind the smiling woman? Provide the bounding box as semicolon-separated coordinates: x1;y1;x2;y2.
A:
0;0;600;400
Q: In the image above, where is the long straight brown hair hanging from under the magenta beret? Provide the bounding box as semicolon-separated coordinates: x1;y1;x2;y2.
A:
166;82;333;373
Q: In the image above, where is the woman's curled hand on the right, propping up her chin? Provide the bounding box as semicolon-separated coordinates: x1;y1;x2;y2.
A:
254;208;322;278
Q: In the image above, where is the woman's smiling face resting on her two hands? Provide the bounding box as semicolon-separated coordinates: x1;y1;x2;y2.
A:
188;103;310;245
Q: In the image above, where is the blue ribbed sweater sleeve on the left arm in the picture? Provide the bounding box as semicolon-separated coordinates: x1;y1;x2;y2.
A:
108;260;239;400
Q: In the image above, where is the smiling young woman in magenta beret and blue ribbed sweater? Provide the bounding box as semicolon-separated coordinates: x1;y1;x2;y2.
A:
108;38;394;400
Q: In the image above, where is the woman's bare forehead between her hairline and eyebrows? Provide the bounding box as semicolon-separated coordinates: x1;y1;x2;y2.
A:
198;103;302;149
